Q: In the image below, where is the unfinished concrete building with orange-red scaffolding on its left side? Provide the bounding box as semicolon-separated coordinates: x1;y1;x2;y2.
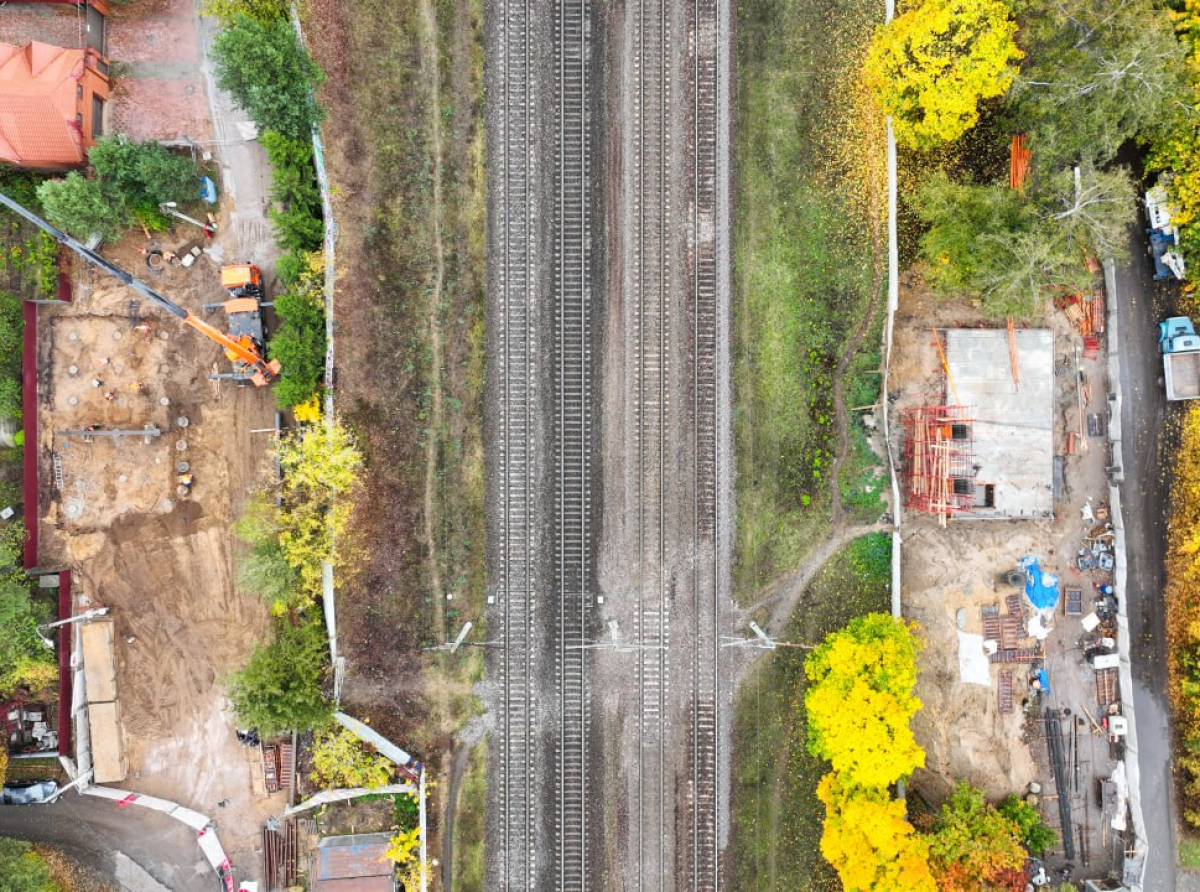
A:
902;329;1054;523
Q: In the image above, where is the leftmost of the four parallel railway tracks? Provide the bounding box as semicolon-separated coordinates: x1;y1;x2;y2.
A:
496;0;540;890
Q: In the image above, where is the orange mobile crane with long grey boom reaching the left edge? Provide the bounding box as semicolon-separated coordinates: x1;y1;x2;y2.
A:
0;192;281;387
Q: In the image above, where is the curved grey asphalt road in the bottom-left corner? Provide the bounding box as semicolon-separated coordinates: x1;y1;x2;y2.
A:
0;792;221;892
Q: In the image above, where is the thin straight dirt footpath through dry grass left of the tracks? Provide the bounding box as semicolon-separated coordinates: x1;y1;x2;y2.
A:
421;0;445;640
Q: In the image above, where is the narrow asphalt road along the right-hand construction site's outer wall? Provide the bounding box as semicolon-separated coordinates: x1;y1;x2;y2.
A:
1116;218;1180;892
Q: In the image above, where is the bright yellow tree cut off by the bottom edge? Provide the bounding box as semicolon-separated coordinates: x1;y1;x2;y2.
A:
817;774;937;892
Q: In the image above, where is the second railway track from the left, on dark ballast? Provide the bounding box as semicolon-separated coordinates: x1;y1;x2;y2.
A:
551;0;594;892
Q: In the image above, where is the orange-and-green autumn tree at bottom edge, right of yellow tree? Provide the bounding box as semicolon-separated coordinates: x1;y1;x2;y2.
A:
929;784;1026;892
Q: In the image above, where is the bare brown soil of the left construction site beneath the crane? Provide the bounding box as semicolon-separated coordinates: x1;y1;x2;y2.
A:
38;247;281;863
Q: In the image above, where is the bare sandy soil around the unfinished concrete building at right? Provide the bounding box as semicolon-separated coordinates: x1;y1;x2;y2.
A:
890;273;1112;876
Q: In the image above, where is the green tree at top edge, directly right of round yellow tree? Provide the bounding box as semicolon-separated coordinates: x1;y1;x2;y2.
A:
1010;0;1195;169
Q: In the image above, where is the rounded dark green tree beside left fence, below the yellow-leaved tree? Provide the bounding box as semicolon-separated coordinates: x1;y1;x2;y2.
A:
229;616;332;737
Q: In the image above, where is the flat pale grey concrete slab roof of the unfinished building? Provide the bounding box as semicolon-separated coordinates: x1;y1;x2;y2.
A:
946;329;1054;517
